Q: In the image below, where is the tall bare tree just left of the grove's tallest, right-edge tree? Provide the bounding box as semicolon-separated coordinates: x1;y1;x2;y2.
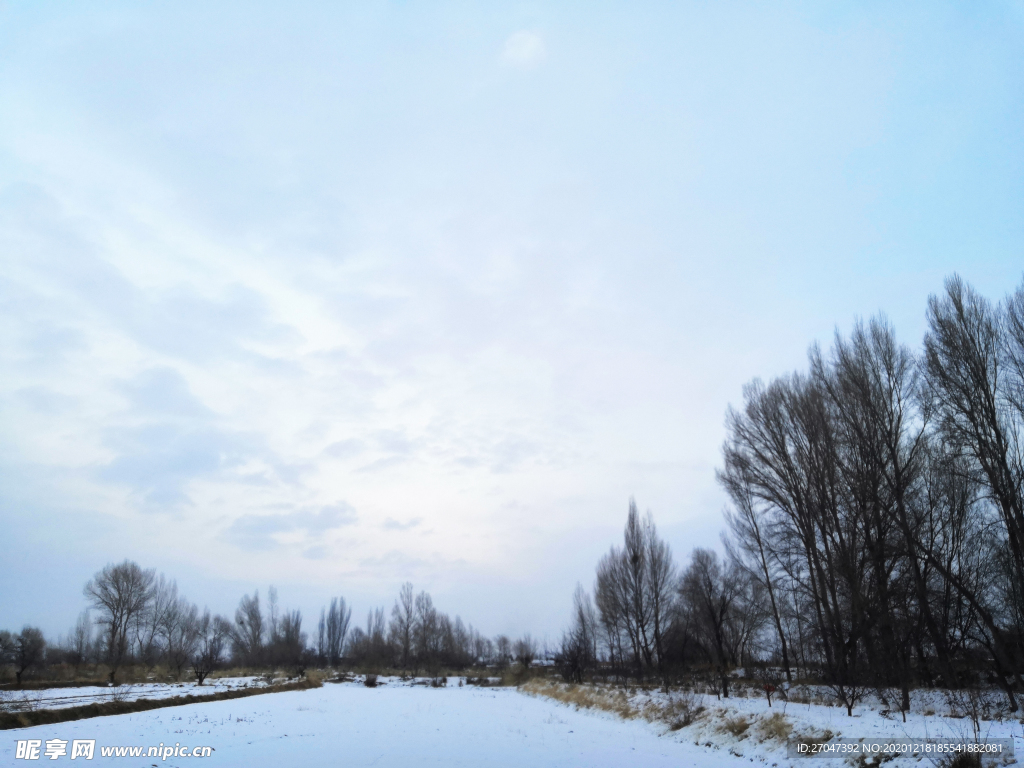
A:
811;317;933;712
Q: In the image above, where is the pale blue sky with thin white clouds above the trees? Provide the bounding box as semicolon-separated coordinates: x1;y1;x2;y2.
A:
0;0;1024;642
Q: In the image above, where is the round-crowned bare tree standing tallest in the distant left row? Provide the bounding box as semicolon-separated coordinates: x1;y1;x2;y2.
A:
84;560;155;683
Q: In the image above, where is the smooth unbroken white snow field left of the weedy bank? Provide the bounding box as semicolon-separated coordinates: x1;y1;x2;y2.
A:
0;684;751;768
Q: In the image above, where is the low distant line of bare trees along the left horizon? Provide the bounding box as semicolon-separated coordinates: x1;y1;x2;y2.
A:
0;560;539;684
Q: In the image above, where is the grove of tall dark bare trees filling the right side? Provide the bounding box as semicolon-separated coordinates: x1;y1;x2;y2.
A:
560;276;1024;711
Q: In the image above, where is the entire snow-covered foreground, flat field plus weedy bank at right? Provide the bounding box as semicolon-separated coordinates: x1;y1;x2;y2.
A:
0;678;1024;768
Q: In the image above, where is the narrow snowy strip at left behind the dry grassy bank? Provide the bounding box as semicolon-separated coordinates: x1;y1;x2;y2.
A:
0;677;268;712
